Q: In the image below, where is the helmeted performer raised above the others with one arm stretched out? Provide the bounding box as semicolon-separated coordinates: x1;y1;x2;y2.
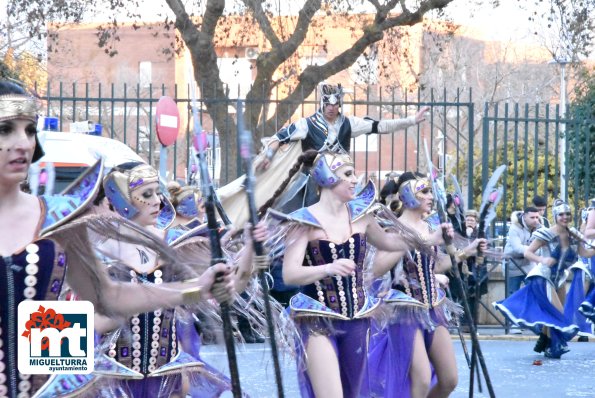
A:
217;83;430;225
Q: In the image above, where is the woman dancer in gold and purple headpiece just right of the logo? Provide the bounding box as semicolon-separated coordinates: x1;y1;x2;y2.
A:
99;162;266;397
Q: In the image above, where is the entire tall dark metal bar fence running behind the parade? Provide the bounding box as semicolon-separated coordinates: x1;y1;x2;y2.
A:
37;83;595;218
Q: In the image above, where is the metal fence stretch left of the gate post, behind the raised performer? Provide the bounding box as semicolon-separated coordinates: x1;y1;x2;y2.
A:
37;83;474;192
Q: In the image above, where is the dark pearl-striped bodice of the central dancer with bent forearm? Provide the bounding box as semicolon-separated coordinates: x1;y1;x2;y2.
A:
302;233;367;318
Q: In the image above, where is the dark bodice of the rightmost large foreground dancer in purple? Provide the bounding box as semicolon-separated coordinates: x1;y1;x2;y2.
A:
399;250;437;307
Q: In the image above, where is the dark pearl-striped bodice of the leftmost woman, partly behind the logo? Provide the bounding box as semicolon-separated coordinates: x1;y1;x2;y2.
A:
0;239;66;398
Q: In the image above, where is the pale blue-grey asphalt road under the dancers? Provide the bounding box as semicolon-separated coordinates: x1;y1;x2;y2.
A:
201;335;595;398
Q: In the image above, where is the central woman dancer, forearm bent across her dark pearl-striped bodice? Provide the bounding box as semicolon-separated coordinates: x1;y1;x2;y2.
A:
269;151;422;397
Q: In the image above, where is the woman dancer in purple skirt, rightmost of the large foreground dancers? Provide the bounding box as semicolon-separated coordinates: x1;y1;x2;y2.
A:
368;172;485;397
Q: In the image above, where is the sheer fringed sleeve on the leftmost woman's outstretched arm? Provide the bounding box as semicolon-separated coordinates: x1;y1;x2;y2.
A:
49;216;199;317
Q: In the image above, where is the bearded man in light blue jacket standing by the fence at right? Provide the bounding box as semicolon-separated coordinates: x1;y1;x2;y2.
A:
504;206;541;296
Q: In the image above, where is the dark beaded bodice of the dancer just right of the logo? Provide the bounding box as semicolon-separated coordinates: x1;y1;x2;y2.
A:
108;269;178;375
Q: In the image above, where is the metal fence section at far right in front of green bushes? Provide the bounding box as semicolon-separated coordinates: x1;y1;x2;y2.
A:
482;103;595;229
